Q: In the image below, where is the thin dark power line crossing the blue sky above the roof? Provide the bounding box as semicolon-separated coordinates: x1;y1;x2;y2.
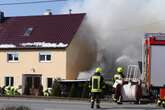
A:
0;0;67;6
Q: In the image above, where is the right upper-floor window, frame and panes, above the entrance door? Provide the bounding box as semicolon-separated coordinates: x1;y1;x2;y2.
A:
39;53;51;62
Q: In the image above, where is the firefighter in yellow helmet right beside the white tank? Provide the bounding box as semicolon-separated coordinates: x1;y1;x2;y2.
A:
112;67;124;104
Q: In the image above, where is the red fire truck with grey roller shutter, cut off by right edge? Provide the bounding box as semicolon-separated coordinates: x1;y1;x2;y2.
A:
142;33;165;107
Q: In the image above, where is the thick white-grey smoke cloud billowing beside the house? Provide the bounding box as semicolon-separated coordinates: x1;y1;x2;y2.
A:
62;0;165;76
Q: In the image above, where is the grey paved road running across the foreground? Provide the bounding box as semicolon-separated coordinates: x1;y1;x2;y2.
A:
0;98;163;110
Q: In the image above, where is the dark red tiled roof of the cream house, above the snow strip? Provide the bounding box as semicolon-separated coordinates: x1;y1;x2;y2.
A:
0;13;85;48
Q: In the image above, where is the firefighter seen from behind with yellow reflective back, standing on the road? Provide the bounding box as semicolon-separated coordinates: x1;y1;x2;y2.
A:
89;67;105;108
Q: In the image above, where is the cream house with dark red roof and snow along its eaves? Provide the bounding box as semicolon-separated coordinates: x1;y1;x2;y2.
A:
0;13;95;95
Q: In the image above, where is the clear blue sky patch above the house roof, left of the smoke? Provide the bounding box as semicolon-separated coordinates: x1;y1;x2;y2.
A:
0;0;83;16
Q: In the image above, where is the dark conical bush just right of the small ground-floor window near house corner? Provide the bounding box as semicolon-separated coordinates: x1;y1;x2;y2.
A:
51;79;61;96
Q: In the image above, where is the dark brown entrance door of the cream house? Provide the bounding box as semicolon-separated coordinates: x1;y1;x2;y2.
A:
23;74;42;96
